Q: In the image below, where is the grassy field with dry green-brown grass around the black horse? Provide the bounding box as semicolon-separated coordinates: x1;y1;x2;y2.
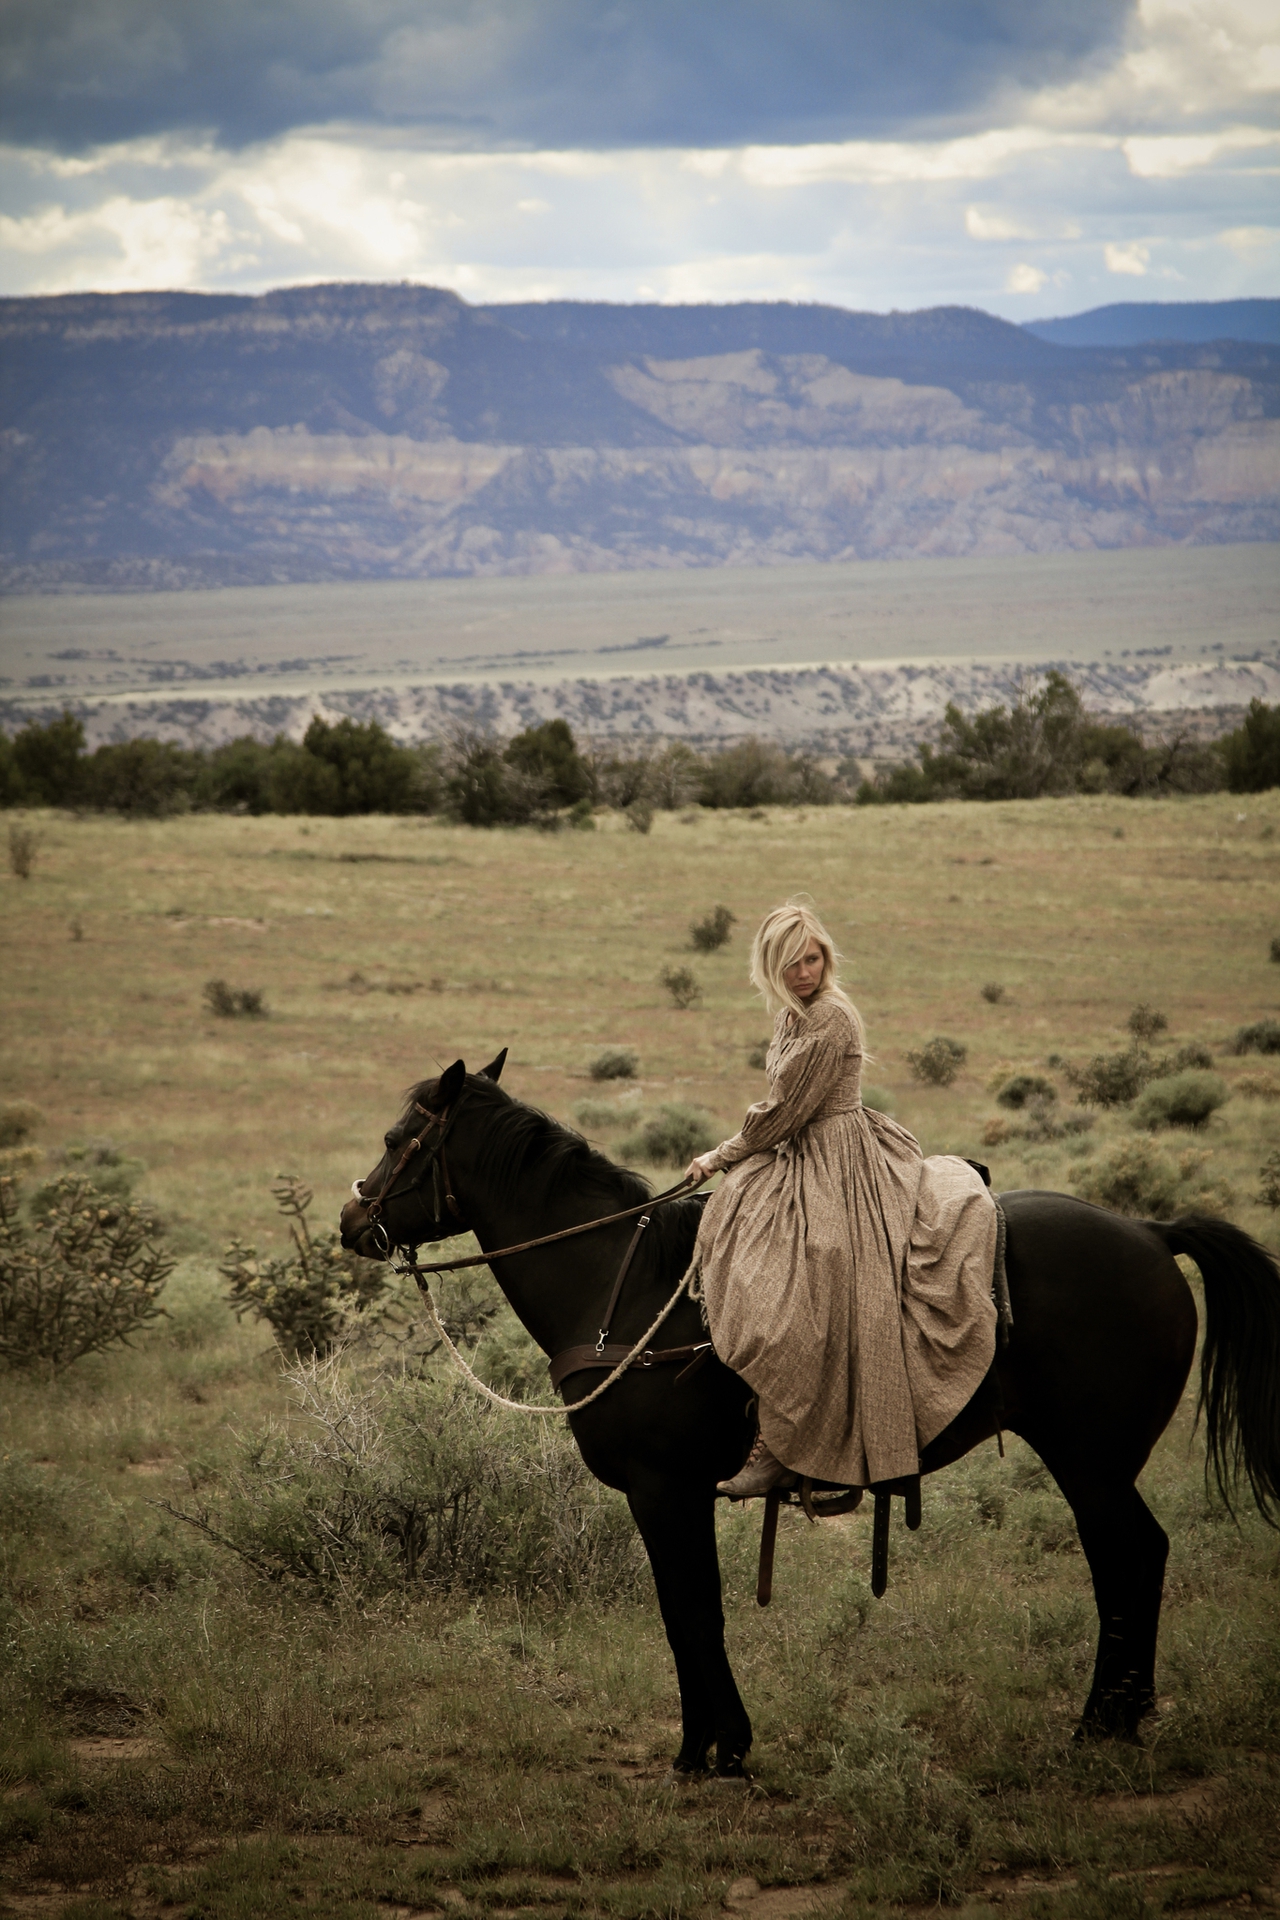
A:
0;793;1280;1920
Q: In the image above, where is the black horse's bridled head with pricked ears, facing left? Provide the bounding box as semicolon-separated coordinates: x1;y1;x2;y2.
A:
340;1046;507;1260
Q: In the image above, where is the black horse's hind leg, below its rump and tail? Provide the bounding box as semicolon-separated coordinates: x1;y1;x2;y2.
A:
1055;1475;1169;1740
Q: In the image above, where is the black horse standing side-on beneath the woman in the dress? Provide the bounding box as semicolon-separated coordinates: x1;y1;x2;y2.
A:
342;1054;1280;1776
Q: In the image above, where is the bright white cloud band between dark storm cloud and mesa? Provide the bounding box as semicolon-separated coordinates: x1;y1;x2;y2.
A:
0;0;1280;319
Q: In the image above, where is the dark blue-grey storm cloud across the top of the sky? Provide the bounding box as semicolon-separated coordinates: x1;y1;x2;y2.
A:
0;0;1136;154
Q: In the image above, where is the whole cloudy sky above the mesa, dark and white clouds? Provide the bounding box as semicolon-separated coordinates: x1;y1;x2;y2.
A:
0;0;1280;319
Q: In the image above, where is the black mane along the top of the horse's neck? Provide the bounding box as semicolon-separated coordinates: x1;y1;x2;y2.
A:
409;1073;702;1252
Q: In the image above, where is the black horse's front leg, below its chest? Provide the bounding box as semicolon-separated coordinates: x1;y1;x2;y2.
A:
628;1478;750;1778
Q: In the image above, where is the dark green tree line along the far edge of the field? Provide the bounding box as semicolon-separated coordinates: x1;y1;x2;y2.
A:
0;672;1280;831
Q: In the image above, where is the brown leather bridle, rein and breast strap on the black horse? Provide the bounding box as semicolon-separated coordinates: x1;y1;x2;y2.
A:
351;1100;712;1388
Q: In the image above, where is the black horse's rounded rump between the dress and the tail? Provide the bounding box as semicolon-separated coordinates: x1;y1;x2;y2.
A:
998;1188;1196;1475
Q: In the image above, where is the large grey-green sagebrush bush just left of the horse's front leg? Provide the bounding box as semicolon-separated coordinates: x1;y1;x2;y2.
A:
169;1357;647;1603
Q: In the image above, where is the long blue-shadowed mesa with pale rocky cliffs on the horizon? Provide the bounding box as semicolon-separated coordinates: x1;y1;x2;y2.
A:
0;288;1280;588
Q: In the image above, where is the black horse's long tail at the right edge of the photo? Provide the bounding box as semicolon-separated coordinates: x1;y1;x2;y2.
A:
1151;1213;1280;1526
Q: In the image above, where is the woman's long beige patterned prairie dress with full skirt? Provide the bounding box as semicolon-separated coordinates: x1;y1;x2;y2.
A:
695;995;996;1486
